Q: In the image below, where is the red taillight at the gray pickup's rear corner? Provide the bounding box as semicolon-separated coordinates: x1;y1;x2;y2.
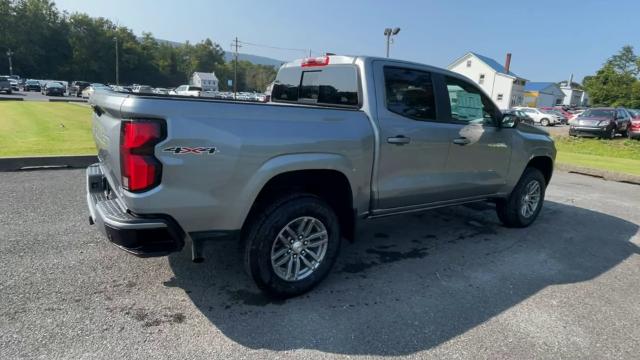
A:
120;120;165;192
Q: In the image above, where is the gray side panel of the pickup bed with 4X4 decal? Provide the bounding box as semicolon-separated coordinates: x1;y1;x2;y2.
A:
116;96;374;232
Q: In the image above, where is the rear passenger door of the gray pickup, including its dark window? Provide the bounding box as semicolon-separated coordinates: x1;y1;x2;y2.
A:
373;61;454;211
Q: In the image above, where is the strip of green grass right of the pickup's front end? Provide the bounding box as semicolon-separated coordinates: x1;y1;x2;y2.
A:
554;136;640;175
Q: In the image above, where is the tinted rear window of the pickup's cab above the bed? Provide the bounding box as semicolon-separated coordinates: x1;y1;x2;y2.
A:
271;60;361;108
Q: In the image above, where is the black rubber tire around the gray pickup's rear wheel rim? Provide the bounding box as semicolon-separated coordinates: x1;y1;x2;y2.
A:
243;193;340;298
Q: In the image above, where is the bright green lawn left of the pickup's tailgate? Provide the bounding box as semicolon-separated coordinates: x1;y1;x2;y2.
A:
0;101;96;157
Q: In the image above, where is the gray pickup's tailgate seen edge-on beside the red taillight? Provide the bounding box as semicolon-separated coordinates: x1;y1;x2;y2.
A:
89;91;129;189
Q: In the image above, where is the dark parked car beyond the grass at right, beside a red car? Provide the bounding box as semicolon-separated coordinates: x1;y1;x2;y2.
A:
569;108;631;139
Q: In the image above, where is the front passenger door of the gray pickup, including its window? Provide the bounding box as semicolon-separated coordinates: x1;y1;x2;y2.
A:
440;76;515;199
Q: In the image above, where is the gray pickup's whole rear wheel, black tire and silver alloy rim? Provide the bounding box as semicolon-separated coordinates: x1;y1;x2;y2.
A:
244;194;340;298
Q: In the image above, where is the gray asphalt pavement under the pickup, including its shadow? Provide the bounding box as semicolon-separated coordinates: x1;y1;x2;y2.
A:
0;170;640;359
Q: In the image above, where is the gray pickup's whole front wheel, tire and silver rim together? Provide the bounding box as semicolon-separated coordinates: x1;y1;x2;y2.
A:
496;168;546;228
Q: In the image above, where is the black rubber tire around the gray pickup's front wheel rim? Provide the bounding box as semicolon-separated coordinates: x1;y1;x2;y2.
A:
496;167;547;228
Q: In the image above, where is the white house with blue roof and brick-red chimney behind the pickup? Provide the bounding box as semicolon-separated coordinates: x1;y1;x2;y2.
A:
447;52;527;109
